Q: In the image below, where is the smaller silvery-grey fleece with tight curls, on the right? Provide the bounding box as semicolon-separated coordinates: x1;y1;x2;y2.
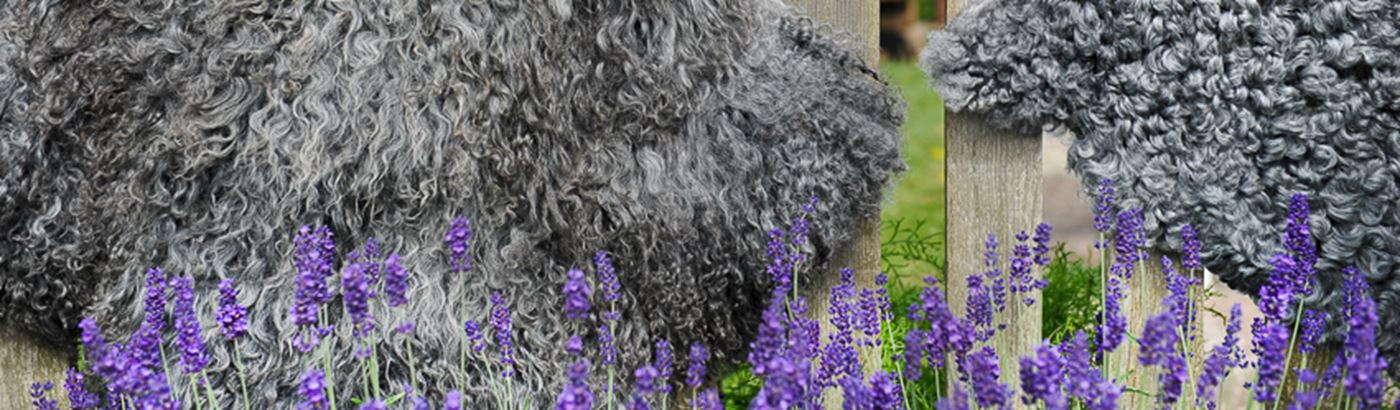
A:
921;0;1400;375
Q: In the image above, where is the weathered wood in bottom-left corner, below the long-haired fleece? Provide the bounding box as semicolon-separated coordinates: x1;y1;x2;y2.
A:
0;325;69;409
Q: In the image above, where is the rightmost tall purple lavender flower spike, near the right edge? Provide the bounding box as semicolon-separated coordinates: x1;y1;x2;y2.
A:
1343;264;1387;409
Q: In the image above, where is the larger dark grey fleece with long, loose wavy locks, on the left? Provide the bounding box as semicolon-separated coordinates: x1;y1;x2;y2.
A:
0;0;903;407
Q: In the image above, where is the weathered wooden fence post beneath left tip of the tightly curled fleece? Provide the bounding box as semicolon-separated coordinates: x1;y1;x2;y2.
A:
944;0;1043;406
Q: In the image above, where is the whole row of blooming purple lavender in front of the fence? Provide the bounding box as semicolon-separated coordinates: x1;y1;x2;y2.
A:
34;190;1387;410
